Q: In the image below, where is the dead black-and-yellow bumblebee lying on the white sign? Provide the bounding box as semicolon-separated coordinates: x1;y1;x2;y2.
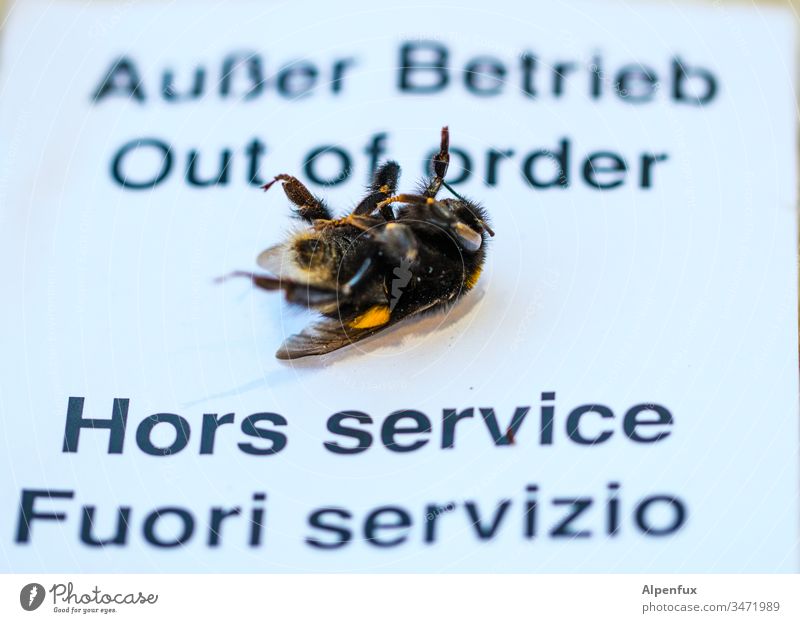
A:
241;127;494;359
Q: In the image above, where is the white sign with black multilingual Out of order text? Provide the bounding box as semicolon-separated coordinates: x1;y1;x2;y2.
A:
0;1;800;572
